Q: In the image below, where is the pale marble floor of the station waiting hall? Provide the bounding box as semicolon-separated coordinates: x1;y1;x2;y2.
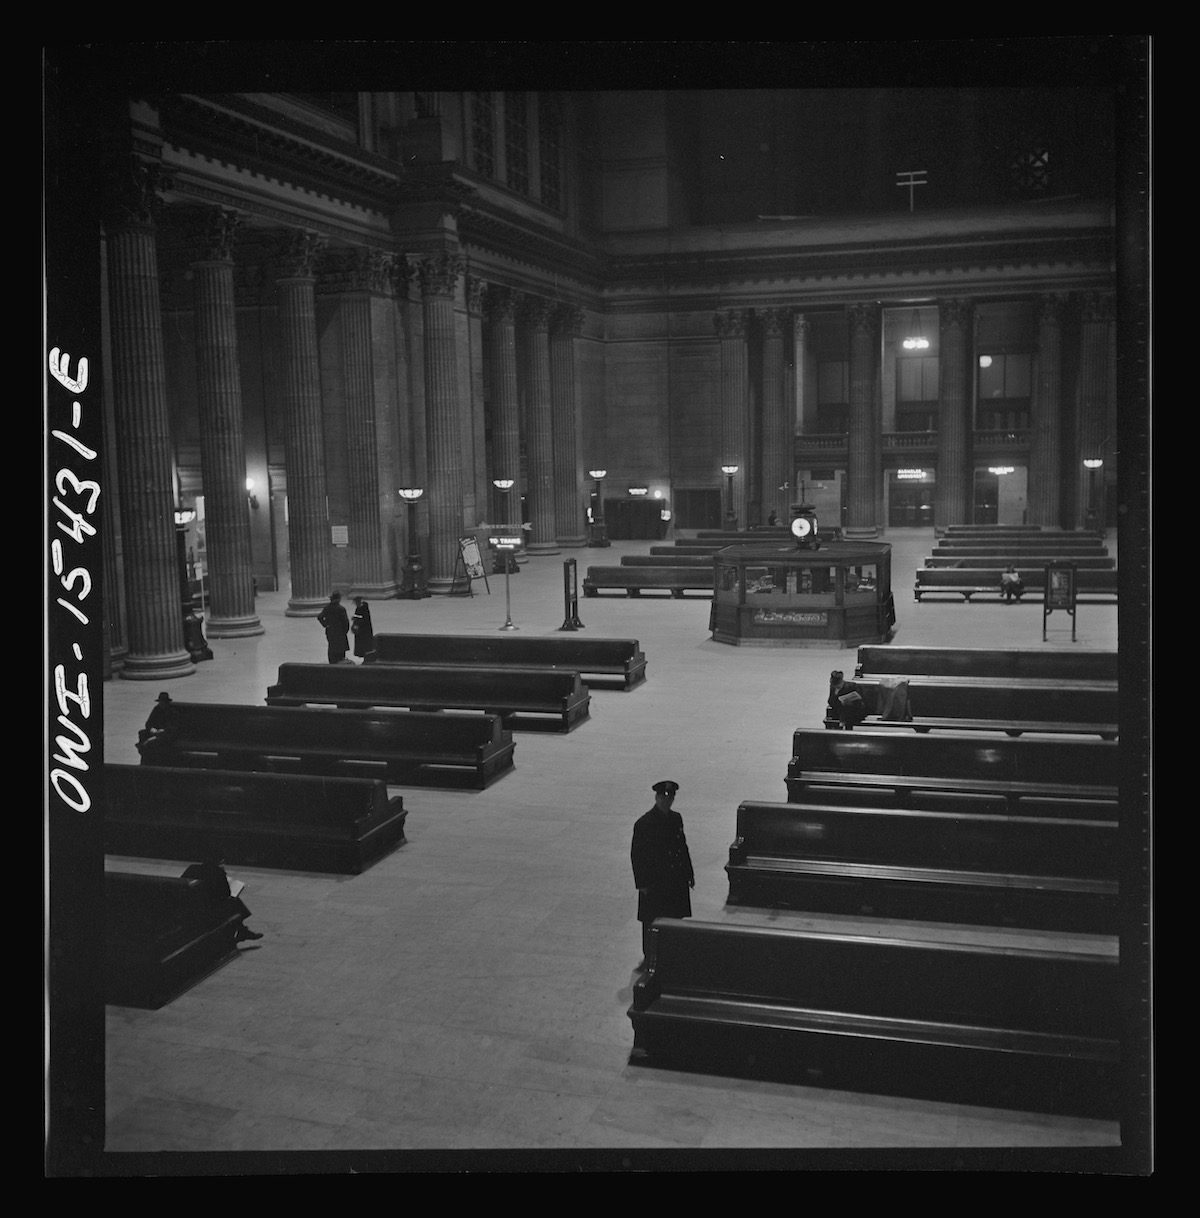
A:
88;530;1140;1174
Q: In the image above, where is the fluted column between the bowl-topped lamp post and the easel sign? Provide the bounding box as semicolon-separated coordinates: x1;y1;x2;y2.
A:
417;252;464;594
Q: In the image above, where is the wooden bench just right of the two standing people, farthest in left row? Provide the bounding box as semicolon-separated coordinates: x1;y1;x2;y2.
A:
367;633;646;689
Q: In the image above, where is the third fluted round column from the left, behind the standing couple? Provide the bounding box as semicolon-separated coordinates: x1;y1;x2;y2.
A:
277;231;330;618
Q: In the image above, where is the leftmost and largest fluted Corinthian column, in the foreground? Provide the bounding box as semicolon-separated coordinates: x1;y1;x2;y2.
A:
106;161;196;681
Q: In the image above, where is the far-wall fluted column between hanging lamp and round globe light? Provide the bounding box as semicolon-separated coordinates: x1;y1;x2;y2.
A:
934;300;975;525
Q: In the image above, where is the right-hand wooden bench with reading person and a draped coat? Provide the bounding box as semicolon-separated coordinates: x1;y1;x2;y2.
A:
825;674;1120;741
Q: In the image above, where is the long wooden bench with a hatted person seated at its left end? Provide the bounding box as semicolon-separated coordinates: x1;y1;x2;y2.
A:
138;696;513;789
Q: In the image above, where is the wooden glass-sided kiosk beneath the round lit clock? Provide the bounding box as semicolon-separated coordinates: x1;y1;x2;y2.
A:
709;542;895;648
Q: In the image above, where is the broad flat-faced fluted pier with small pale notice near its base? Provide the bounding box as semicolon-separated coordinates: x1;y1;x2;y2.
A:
326;248;397;597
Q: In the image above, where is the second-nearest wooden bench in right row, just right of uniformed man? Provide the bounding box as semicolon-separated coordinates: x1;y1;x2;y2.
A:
725;803;1118;934
